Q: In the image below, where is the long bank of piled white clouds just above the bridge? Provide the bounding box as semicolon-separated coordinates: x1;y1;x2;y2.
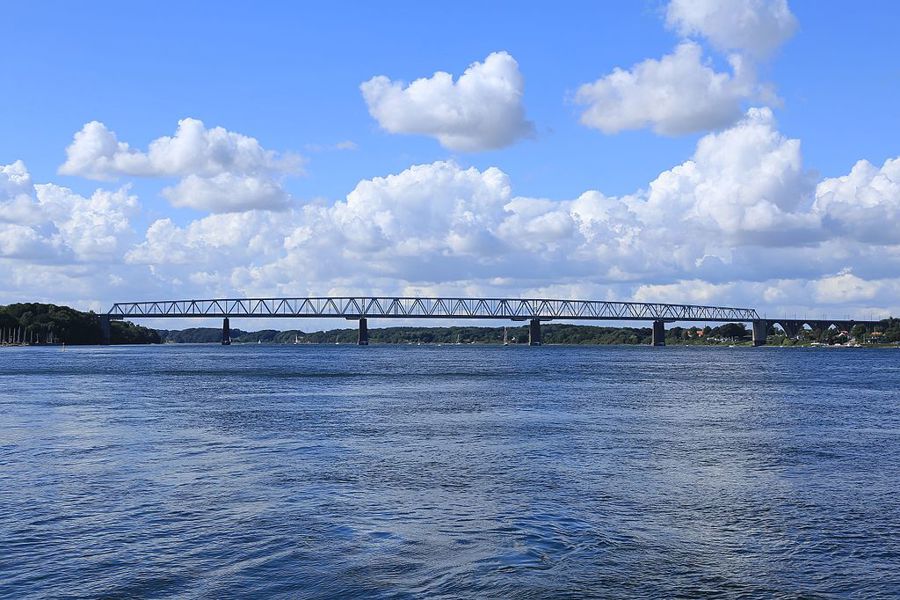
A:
8;108;900;315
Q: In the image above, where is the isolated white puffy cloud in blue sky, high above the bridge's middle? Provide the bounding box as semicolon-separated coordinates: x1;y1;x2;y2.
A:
360;52;533;152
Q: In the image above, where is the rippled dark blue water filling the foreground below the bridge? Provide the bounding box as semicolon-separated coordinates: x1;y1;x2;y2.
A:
0;346;900;599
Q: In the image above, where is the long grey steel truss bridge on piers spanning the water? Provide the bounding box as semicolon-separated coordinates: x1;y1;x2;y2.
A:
101;296;875;346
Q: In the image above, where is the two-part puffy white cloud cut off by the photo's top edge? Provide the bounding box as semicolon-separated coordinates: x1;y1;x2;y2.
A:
575;0;796;135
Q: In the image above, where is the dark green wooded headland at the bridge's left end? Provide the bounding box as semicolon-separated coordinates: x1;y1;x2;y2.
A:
0;302;161;345
